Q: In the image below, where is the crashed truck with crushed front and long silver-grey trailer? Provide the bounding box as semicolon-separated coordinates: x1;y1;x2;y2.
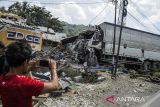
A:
69;22;160;70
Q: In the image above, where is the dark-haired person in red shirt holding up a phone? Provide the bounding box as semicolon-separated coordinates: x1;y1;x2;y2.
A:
0;42;60;107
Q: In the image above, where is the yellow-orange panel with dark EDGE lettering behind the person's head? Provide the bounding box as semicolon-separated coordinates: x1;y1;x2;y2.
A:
0;25;42;51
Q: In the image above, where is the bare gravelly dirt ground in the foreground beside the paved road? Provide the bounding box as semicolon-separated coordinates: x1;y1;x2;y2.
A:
39;74;160;107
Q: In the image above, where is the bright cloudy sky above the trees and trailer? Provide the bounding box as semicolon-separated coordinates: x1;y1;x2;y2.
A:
0;0;160;34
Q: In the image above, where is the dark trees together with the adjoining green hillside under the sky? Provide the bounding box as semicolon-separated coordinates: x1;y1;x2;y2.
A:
0;2;92;36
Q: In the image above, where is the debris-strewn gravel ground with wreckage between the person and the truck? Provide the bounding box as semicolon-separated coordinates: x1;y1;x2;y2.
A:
29;39;160;107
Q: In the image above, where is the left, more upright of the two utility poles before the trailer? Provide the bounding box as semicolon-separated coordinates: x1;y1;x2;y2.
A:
112;0;118;77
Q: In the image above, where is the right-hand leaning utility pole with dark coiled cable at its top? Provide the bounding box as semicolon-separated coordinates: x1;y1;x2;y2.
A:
113;0;128;78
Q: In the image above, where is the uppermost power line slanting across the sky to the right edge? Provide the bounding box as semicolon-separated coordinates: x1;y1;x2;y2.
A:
130;0;160;32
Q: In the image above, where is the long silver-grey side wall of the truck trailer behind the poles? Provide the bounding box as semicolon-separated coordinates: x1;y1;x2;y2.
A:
100;22;160;61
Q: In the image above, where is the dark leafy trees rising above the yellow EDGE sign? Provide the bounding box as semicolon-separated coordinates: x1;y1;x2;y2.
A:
8;2;63;32
